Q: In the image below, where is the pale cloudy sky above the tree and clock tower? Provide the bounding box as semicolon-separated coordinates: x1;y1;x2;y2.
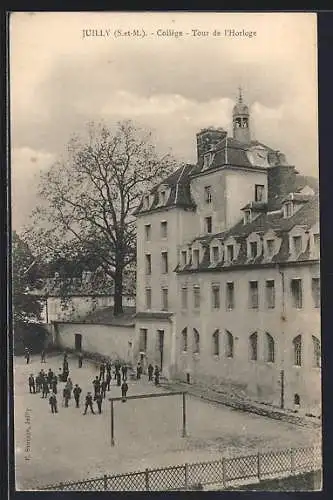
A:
10;12;318;230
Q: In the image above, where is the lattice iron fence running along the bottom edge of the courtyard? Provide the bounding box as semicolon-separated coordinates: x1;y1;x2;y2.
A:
43;446;322;491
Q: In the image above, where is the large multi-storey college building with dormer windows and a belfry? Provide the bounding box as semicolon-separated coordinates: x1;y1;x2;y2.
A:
134;89;321;413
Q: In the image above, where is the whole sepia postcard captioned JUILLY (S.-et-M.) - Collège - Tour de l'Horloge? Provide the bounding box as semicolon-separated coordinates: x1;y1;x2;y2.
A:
9;11;322;492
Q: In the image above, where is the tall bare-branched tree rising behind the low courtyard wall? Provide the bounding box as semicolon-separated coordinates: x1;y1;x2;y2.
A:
25;121;173;315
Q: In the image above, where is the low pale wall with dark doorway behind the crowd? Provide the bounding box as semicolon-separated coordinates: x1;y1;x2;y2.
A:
55;322;134;363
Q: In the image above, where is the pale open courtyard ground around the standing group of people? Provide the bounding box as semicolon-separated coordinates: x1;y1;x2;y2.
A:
14;356;320;490
